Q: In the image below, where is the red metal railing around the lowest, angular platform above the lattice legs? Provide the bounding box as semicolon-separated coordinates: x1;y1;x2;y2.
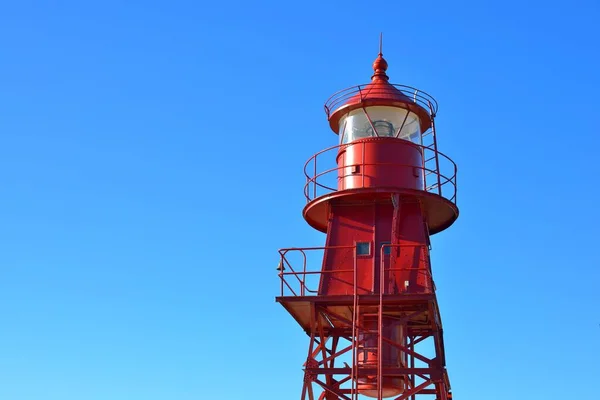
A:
278;243;435;296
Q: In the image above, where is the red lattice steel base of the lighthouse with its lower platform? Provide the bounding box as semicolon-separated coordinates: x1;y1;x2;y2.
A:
276;247;452;400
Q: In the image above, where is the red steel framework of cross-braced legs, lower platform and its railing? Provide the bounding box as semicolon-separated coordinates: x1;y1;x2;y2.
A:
276;244;451;400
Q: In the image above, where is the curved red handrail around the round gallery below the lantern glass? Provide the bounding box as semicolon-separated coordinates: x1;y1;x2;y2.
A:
304;142;458;204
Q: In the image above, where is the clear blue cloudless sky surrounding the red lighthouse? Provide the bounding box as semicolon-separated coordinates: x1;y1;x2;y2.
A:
0;0;600;400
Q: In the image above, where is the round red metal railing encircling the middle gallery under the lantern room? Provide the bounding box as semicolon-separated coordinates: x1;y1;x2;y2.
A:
304;141;457;204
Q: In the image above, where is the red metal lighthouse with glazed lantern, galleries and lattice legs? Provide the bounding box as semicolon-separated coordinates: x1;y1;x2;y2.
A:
276;47;458;400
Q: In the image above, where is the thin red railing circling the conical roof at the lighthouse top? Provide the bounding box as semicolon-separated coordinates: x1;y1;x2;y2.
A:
325;83;438;118
